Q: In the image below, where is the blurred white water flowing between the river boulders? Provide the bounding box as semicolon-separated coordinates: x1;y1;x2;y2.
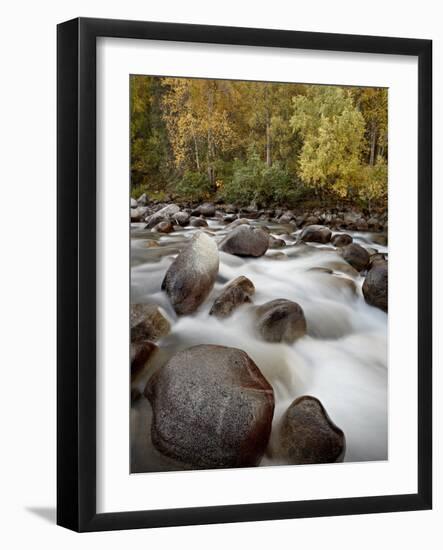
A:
131;220;388;472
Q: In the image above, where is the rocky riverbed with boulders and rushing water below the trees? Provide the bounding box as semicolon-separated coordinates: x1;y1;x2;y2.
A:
131;196;388;472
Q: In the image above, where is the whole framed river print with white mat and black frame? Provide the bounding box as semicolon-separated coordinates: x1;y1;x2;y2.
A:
57;18;432;531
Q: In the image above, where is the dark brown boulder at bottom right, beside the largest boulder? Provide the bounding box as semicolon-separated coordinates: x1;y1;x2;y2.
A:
278;395;346;464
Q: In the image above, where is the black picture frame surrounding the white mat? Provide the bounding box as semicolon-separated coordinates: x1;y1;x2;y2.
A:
57;18;432;531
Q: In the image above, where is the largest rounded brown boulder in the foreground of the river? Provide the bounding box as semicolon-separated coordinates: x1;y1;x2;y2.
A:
145;345;274;469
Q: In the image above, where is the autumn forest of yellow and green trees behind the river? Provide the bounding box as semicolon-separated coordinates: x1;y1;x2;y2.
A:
130;75;388;211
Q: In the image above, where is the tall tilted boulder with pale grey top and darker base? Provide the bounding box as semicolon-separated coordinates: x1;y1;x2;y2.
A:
162;232;219;315
